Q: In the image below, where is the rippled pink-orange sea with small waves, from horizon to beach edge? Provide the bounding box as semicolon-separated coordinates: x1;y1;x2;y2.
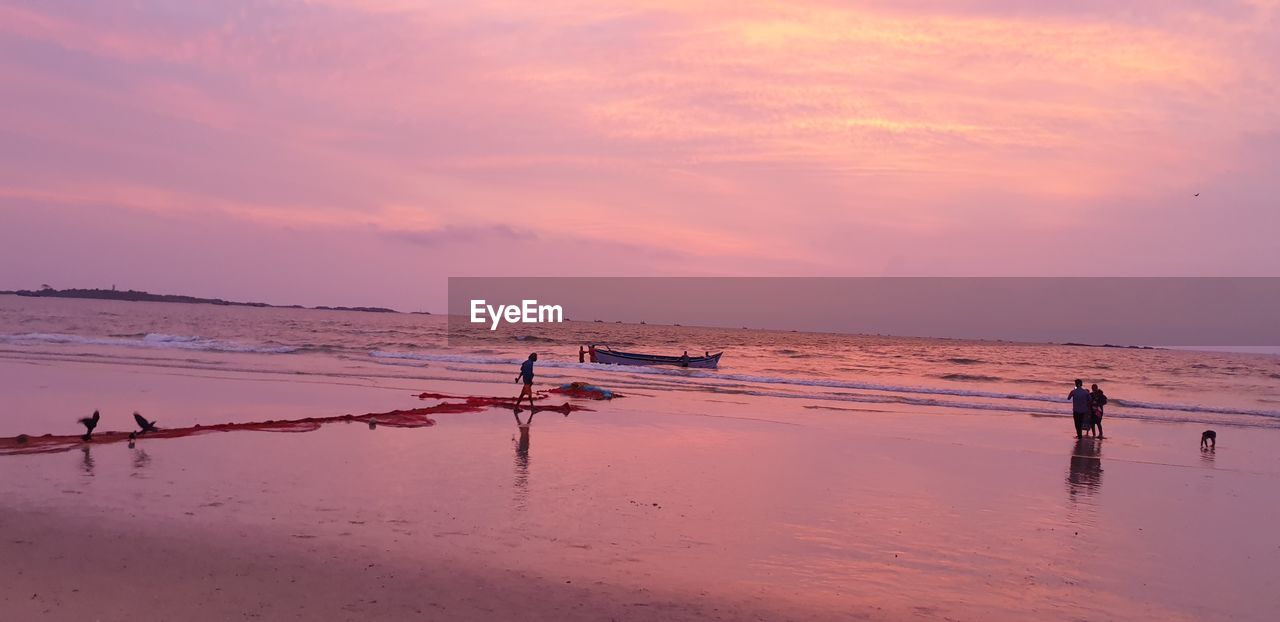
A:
0;296;1280;427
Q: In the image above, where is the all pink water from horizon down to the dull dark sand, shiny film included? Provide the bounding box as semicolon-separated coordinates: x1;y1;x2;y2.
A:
0;298;1280;619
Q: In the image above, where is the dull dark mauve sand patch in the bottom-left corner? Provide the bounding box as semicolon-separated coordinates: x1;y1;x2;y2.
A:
0;504;835;621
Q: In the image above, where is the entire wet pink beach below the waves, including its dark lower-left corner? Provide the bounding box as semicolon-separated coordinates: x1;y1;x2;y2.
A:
0;361;1280;619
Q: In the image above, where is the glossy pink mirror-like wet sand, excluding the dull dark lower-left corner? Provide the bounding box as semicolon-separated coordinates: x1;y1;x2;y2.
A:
0;361;1280;619
